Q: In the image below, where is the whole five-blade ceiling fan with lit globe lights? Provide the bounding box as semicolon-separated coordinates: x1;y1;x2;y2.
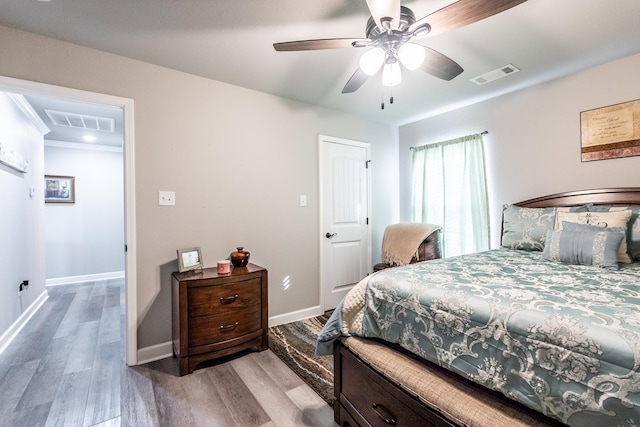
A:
273;0;526;96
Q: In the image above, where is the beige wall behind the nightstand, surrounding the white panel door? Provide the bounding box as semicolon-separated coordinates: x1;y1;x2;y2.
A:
0;27;398;347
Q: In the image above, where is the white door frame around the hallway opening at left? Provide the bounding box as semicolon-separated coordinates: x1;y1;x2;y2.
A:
0;76;138;366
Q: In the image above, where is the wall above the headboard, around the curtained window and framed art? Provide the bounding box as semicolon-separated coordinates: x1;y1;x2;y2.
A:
399;55;640;247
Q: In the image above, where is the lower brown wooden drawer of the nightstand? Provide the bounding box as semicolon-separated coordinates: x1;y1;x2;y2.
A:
189;305;262;348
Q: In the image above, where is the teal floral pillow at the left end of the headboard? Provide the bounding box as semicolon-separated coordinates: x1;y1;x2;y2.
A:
502;205;556;251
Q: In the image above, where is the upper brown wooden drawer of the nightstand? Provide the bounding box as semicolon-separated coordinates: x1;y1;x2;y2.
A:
187;278;262;317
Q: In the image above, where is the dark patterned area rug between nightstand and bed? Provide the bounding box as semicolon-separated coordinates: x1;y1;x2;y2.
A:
269;312;335;406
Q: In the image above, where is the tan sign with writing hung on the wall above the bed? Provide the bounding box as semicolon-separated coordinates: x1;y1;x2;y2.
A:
580;100;640;162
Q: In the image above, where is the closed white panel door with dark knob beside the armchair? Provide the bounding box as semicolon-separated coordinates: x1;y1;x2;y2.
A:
319;135;371;310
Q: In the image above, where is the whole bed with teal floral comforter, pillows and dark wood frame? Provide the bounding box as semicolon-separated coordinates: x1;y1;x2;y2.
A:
316;188;640;427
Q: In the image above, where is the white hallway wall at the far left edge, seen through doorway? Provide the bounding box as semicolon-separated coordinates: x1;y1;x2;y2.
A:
0;92;45;335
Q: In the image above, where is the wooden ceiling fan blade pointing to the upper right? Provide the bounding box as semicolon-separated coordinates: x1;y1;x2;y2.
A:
409;0;527;36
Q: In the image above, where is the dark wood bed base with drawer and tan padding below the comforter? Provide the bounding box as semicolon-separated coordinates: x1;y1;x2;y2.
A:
334;337;562;427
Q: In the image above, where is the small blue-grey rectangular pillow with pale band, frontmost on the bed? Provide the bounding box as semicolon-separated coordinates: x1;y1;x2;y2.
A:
540;225;626;270
